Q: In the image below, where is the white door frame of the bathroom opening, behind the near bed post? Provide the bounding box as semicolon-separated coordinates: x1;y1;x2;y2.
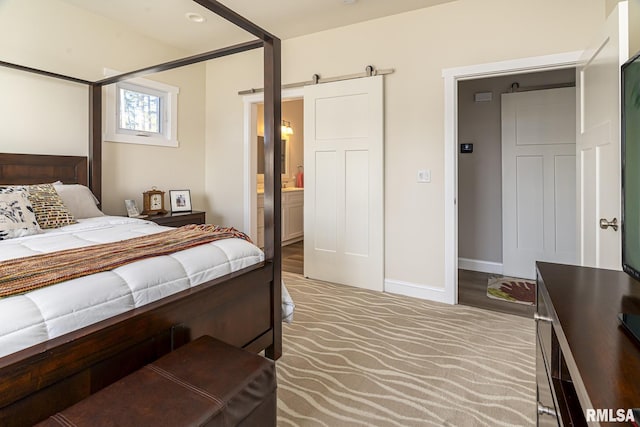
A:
242;86;304;241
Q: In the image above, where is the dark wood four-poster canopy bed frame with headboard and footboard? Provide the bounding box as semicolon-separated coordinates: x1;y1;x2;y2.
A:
0;0;282;426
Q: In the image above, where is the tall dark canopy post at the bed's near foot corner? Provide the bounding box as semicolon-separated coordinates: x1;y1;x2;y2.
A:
264;37;282;360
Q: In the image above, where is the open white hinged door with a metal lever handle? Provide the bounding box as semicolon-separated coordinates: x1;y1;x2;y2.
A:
577;2;629;270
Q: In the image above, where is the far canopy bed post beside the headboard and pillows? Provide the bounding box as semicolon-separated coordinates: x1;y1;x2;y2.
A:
89;84;102;203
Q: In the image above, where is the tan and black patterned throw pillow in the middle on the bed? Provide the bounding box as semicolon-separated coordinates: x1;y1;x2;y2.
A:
25;184;78;229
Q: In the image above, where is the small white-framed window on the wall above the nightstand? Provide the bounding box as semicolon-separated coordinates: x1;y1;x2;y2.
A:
104;72;179;147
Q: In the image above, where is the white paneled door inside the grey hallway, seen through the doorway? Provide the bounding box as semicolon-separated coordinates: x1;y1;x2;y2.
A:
502;88;576;279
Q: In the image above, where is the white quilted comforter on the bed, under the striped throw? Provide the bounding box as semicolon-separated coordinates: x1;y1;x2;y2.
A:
0;216;264;357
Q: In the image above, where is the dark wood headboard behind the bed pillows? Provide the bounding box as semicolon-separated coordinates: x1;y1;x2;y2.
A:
0;153;87;185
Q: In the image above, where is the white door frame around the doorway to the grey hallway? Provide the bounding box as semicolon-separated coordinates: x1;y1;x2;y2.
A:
442;51;582;304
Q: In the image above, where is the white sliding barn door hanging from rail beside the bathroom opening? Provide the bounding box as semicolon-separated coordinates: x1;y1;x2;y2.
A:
304;76;384;291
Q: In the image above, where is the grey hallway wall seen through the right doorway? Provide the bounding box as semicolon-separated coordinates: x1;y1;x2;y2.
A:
458;69;575;263
